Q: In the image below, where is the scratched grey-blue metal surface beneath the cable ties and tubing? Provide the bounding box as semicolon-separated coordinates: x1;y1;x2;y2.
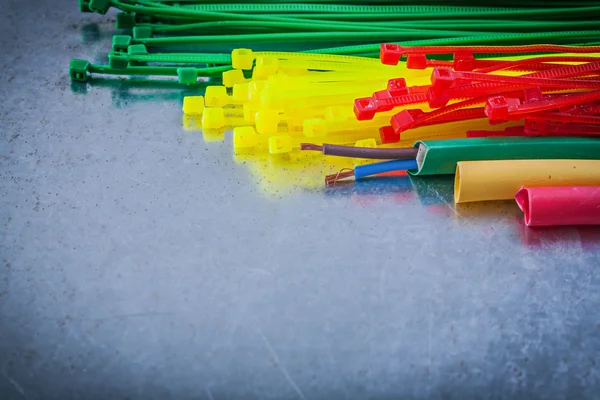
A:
0;0;600;400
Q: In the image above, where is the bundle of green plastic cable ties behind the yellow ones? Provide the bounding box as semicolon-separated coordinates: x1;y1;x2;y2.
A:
71;0;600;85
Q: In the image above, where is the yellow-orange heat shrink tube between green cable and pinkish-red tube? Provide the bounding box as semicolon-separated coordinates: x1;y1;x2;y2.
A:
454;160;600;203
